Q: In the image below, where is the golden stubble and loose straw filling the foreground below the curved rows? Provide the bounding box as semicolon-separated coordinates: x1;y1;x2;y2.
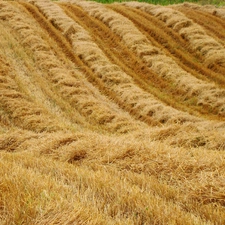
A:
1;127;225;224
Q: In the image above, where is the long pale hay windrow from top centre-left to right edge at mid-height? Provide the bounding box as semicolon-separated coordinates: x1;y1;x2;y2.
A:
72;1;225;116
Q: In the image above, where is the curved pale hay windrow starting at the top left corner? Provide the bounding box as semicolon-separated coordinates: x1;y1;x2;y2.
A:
2;0;146;134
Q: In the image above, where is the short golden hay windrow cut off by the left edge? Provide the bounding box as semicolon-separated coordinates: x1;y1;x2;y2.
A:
0;52;63;132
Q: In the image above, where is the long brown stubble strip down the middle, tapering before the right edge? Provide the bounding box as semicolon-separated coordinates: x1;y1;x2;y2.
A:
59;4;206;120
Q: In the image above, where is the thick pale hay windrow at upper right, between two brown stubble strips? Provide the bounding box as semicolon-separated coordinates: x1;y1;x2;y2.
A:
129;1;225;71
